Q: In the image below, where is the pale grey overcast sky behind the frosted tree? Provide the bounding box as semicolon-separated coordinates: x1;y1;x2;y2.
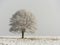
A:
0;0;60;36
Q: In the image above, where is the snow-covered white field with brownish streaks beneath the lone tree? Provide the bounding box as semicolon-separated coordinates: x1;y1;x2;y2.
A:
0;37;60;45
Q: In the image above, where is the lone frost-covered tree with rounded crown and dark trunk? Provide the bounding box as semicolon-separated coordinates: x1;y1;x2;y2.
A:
9;10;35;38
